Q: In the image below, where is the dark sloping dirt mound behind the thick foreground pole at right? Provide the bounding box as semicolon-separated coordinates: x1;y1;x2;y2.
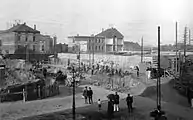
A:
140;80;189;106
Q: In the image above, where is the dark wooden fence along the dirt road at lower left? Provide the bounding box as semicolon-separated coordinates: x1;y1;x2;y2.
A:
0;83;59;102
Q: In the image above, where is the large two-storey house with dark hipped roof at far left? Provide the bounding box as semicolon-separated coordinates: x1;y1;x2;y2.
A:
0;23;53;54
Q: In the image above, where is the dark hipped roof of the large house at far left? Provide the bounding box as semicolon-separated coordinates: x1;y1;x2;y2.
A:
1;23;40;33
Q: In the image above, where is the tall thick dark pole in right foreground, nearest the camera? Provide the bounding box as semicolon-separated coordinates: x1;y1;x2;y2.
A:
157;26;161;110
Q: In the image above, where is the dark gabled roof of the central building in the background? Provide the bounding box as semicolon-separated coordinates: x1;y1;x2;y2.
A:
96;28;124;39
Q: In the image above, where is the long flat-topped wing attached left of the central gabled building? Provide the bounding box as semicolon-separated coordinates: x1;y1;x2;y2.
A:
68;35;105;53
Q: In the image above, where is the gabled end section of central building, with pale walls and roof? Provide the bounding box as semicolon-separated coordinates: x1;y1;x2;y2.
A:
96;28;124;53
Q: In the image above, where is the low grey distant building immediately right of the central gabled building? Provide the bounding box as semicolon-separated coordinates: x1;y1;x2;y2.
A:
123;41;141;51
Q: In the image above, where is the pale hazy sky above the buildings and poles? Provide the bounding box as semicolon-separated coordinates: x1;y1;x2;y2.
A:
0;0;193;46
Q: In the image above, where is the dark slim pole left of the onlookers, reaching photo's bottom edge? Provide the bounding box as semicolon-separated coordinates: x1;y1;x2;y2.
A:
72;66;76;120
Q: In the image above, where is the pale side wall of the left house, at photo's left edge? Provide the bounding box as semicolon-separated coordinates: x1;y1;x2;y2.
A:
0;32;16;54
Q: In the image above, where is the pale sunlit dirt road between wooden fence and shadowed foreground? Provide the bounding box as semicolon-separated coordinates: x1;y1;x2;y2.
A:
0;86;129;120
